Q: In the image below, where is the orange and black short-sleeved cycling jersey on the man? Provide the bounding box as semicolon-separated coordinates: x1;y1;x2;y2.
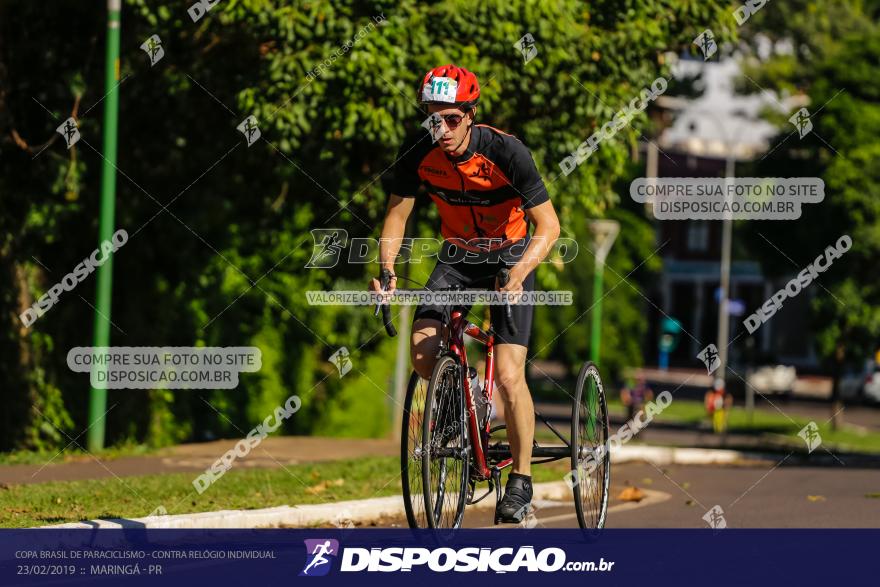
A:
388;124;549;251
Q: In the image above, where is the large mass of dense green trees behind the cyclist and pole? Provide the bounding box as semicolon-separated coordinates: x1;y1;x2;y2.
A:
0;0;733;448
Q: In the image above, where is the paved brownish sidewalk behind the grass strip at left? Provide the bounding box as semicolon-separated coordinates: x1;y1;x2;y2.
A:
0;436;400;486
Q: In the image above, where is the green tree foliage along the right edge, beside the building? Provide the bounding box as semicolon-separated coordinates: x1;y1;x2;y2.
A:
747;0;880;375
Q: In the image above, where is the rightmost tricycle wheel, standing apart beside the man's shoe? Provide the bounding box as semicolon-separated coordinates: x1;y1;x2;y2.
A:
570;361;611;530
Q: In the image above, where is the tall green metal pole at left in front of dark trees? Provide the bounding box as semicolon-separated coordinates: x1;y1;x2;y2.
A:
88;0;122;451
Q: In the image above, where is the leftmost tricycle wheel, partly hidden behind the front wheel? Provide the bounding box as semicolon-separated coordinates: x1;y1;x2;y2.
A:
400;371;428;528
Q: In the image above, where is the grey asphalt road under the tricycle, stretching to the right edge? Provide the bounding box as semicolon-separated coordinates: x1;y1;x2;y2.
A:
388;464;880;528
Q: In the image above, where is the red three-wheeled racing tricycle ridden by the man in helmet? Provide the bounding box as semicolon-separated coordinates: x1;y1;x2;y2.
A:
376;269;611;530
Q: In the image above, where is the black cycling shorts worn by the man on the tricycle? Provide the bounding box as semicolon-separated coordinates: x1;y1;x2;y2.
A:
413;247;535;347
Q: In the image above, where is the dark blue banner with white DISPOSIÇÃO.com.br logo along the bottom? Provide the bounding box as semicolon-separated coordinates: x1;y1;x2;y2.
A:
0;532;880;587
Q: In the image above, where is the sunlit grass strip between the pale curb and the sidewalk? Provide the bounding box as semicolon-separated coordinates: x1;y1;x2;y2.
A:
0;457;568;528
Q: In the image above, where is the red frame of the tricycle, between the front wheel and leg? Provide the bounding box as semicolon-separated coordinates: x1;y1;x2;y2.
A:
441;310;513;481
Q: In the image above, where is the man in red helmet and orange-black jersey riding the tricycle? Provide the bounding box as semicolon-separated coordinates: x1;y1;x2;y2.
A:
370;65;559;523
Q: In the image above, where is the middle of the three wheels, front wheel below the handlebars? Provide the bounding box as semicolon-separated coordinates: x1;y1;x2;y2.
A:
422;355;470;528
